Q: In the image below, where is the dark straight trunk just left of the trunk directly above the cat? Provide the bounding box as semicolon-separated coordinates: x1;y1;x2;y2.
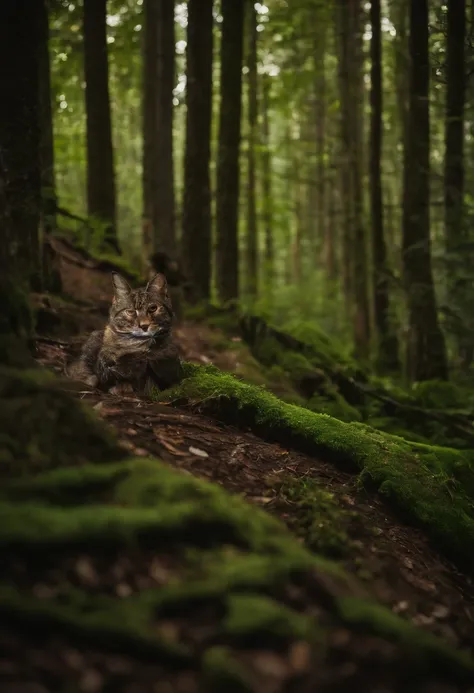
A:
84;0;120;252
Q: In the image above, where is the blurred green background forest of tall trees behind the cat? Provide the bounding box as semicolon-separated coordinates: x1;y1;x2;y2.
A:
16;0;474;381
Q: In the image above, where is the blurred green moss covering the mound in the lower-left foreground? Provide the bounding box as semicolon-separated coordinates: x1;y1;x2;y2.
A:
0;459;474;690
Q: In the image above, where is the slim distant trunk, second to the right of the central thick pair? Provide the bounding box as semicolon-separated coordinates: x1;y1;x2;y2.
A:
261;75;275;292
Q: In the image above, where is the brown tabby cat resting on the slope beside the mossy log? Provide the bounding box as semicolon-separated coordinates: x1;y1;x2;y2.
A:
68;272;182;394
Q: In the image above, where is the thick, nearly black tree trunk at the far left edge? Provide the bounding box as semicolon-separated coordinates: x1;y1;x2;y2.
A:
0;0;41;290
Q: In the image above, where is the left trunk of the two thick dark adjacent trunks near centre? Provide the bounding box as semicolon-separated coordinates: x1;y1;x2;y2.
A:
182;0;213;301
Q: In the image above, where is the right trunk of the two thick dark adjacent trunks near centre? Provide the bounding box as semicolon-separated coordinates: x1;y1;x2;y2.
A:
216;0;244;302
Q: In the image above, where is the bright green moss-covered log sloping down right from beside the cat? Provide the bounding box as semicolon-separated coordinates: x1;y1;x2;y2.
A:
161;365;474;567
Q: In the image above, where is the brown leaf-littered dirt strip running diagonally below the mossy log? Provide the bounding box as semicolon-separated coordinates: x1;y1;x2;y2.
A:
37;329;474;652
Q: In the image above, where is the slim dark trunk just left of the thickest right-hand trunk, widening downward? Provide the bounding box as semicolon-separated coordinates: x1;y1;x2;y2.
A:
370;0;399;370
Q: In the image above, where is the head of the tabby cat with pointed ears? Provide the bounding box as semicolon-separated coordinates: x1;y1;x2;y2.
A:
109;272;173;341
